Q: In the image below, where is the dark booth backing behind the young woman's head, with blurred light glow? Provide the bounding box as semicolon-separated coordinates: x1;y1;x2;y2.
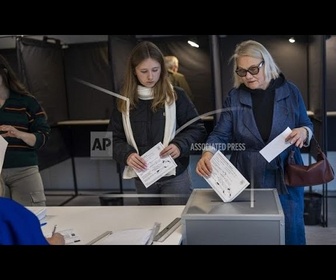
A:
109;35;215;114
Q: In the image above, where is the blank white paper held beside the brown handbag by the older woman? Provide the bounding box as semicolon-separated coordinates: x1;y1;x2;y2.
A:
259;127;292;162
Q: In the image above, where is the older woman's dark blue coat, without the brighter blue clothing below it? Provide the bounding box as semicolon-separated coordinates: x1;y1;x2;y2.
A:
207;81;313;192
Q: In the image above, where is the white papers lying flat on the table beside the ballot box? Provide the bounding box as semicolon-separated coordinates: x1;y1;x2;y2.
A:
87;223;160;245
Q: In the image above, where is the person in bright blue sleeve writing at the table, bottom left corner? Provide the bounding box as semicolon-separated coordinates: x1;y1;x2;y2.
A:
0;197;65;245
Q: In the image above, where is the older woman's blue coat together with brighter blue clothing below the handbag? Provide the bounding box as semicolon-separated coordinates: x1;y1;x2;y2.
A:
207;81;313;245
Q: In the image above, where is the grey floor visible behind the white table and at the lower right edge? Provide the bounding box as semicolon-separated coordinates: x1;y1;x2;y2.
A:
47;189;336;245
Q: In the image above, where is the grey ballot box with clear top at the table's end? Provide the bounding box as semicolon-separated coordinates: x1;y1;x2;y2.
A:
181;188;285;245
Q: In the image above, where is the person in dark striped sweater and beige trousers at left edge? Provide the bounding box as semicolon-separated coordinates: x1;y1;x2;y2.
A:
0;55;50;206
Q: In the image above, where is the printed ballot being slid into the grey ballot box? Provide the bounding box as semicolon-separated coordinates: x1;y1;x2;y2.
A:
204;151;250;202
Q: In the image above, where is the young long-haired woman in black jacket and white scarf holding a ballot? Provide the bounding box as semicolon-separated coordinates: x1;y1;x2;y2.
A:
108;41;207;204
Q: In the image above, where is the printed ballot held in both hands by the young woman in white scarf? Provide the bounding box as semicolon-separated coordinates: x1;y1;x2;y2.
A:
134;142;177;188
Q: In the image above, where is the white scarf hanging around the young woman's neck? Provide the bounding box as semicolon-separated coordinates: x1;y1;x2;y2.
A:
122;86;176;179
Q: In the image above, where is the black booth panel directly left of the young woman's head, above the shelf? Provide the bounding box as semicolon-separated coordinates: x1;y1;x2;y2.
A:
64;42;112;120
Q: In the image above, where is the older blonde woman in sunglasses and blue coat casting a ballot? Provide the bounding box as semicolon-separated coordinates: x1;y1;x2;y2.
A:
196;40;313;245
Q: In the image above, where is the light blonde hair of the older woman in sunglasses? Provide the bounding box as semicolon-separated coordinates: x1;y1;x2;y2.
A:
230;40;281;88
